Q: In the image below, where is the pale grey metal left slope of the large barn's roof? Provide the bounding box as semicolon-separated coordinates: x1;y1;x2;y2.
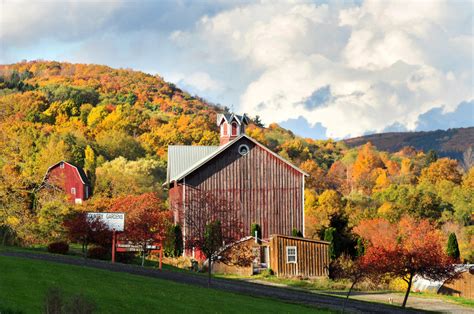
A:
166;145;219;182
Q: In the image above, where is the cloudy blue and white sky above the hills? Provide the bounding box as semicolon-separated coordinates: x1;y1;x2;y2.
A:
0;0;474;138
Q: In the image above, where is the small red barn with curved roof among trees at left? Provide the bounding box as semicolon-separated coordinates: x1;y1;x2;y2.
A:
41;161;91;204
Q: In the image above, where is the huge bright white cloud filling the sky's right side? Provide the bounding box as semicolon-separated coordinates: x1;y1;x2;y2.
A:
173;1;473;138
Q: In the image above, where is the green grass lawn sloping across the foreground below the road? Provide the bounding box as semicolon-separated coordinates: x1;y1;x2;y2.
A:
0;256;331;313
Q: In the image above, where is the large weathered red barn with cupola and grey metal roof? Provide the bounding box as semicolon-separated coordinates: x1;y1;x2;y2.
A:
167;114;330;278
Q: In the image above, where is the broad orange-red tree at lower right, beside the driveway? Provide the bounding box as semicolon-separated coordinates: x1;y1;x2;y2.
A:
354;217;454;307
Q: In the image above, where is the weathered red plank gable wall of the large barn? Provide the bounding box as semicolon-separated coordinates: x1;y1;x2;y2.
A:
178;138;304;238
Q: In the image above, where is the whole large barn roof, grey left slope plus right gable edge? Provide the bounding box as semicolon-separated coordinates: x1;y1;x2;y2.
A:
166;134;308;183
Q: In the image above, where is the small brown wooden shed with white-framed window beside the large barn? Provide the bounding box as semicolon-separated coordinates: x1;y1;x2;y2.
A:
269;234;330;277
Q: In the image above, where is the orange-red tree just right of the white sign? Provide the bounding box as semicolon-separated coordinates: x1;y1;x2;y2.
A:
111;193;172;266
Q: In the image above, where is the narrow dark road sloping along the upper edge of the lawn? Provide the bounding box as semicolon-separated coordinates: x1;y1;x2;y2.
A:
0;252;446;313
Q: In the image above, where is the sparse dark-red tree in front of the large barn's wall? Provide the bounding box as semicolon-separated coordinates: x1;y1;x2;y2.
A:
184;190;245;284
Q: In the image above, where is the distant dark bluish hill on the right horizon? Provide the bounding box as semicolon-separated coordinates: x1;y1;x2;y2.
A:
344;127;474;166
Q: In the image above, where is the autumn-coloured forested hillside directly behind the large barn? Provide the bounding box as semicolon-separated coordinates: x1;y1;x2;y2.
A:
0;61;474;261
